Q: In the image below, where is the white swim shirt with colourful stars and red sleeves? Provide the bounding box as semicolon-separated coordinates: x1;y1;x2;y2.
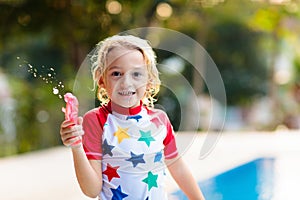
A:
84;102;178;200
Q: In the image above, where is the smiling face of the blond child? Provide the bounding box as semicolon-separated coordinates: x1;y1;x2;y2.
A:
104;48;148;108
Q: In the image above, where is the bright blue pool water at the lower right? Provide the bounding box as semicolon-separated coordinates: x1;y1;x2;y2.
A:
174;158;275;200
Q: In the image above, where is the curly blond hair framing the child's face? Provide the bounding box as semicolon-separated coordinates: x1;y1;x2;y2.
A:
91;35;161;108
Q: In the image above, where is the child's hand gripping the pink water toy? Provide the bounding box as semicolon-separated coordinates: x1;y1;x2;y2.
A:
60;117;84;148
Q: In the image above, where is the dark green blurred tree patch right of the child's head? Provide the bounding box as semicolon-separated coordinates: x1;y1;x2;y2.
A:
206;19;268;105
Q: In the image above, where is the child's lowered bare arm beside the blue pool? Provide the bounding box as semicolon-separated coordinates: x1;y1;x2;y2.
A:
166;157;205;200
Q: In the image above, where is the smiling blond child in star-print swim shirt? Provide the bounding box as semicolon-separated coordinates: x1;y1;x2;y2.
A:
60;35;204;200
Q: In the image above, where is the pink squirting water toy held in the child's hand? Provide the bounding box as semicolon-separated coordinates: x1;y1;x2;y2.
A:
62;93;81;146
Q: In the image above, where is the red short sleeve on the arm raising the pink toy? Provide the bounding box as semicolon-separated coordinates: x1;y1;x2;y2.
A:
82;108;107;160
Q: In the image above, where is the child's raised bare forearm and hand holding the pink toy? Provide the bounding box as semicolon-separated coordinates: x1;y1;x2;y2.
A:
60;117;102;198
